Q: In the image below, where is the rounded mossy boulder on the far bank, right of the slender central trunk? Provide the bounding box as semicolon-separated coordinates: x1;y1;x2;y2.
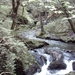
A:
44;18;71;33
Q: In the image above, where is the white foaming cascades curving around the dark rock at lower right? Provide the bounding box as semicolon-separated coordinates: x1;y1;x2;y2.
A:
34;50;75;75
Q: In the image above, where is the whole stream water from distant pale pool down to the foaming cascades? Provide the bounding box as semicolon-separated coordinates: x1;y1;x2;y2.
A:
22;30;75;75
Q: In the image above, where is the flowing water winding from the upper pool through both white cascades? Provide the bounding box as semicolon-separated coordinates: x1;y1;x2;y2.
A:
22;31;75;75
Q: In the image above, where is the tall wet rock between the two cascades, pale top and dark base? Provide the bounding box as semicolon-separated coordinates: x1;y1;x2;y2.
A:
46;50;66;70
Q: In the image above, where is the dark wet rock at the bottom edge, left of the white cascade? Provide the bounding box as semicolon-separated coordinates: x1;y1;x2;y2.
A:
25;64;41;75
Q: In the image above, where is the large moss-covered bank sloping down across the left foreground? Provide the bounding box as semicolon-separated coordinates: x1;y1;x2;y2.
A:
0;25;36;72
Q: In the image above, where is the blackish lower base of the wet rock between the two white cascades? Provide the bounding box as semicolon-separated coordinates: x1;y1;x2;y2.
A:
48;60;66;70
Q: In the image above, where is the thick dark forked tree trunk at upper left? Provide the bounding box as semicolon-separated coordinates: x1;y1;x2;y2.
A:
11;0;20;30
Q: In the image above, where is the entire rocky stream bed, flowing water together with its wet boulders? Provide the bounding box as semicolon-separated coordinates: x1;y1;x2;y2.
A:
22;30;75;75
